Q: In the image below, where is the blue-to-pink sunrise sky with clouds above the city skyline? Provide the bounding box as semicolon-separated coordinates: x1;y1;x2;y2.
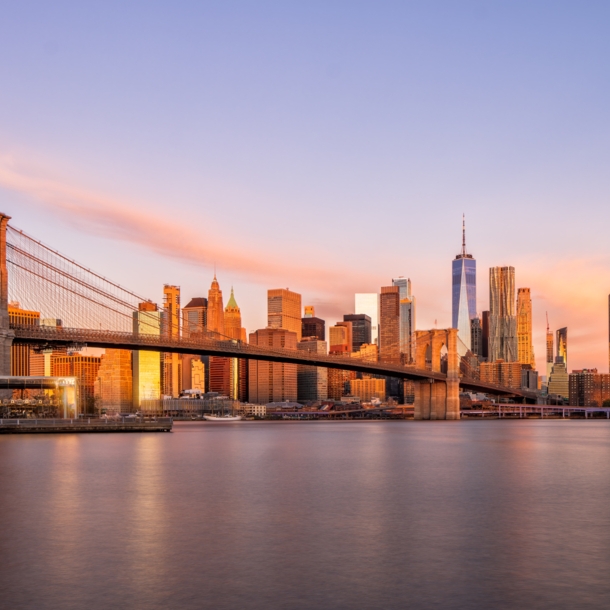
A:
0;0;610;372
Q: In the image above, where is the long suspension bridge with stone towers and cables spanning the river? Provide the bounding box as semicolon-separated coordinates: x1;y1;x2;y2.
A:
0;214;537;419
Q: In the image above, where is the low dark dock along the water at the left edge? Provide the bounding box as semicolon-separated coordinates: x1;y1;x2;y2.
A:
0;417;174;434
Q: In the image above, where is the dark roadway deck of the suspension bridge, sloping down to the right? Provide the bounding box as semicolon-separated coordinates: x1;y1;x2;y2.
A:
11;325;536;400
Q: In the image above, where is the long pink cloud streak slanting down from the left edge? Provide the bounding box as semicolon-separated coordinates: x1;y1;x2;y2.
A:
0;160;373;292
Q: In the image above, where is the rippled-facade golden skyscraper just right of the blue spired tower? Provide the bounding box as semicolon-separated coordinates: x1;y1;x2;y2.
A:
489;267;517;362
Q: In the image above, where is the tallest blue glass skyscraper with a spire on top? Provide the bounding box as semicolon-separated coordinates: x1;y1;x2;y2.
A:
451;219;477;356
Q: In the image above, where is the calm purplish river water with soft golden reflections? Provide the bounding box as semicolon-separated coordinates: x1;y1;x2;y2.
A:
0;421;610;610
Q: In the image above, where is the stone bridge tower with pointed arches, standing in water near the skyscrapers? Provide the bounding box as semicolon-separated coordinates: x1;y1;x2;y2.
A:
414;328;460;419
